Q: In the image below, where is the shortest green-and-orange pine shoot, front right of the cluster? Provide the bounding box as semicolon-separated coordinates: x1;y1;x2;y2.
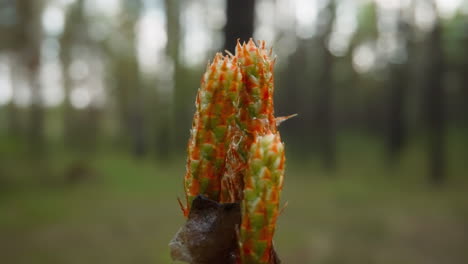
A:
239;134;285;264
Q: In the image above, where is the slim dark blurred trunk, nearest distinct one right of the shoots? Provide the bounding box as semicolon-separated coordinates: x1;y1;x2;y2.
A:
316;0;336;170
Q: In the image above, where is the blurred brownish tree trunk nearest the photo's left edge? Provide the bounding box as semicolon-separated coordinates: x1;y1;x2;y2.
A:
16;0;44;153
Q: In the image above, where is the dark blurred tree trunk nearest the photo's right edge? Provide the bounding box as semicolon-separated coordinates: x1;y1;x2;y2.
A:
423;17;445;184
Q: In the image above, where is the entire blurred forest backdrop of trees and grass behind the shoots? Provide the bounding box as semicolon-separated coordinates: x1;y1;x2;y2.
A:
0;0;468;264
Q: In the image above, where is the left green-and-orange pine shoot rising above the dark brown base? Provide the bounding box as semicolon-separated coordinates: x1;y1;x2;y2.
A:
184;53;242;212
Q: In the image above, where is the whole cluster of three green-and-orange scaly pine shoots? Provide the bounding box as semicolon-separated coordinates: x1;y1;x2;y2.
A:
183;40;285;264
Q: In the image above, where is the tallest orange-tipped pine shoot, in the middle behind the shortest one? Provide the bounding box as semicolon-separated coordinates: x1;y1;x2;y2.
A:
221;39;276;202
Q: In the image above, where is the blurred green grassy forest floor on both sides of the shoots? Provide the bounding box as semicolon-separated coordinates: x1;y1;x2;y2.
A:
0;133;468;264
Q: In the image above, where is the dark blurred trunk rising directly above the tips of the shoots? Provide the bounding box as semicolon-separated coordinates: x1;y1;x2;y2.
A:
224;0;255;53
